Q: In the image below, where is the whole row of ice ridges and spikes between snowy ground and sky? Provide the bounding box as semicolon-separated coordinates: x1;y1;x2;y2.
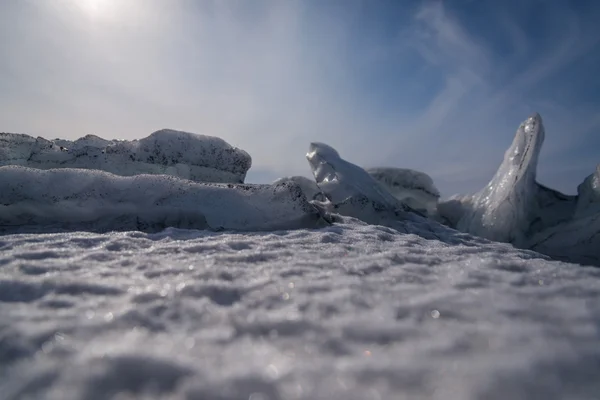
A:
0;114;600;265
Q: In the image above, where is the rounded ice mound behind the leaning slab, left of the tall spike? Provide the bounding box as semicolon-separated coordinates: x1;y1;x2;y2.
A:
367;167;440;215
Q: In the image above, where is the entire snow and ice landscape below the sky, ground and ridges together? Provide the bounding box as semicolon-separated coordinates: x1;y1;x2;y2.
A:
0;114;600;400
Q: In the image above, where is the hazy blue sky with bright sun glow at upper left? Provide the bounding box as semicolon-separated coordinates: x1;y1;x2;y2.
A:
0;0;600;195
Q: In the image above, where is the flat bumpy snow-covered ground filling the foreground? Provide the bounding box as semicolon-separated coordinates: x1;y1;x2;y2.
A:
0;218;600;400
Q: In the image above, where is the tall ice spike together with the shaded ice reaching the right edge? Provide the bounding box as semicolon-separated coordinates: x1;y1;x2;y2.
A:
434;114;600;265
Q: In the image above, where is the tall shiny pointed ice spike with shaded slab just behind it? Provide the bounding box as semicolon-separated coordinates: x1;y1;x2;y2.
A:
454;114;576;247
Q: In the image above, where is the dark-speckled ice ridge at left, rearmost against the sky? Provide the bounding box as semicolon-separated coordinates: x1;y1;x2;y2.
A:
0;129;252;183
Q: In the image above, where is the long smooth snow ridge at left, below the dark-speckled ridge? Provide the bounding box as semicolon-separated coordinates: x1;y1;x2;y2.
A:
0;166;326;232
